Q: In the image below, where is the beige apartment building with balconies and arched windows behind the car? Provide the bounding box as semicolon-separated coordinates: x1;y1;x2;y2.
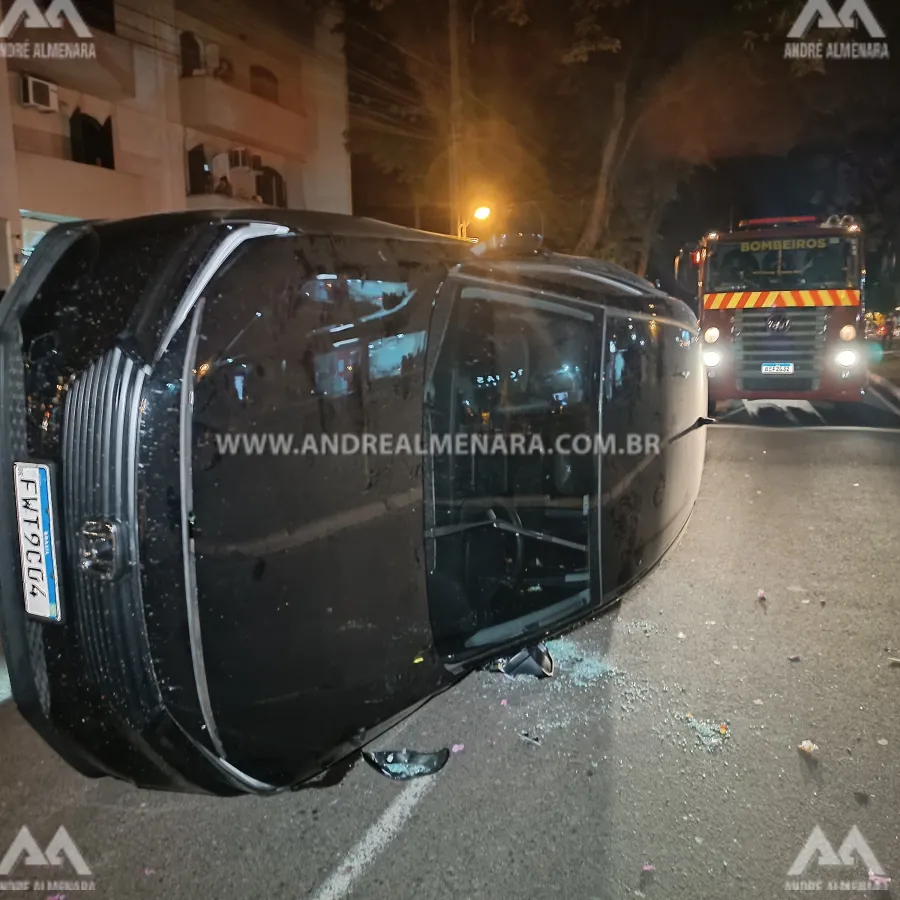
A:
0;0;351;289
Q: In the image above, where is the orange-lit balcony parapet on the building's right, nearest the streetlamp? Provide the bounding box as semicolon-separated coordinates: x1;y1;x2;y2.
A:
181;75;308;157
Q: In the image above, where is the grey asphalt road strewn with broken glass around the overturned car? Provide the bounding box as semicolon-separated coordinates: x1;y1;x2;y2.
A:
0;389;900;900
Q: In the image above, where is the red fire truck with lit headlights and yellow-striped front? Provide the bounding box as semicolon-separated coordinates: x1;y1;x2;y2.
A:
675;216;868;415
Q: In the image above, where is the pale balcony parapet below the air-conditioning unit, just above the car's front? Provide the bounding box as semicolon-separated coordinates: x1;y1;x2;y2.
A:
16;151;151;219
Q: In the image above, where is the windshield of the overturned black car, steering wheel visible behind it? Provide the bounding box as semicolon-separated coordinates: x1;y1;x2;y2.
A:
426;287;599;655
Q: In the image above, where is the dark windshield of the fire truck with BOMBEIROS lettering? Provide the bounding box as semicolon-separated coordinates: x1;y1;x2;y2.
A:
706;235;860;293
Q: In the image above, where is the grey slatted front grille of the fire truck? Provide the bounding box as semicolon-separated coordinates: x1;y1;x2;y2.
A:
734;307;827;391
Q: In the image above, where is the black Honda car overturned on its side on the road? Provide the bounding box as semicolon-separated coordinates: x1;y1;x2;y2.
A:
0;210;707;795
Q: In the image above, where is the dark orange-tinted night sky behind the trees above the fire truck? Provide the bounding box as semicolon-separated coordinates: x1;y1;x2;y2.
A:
346;0;900;305
